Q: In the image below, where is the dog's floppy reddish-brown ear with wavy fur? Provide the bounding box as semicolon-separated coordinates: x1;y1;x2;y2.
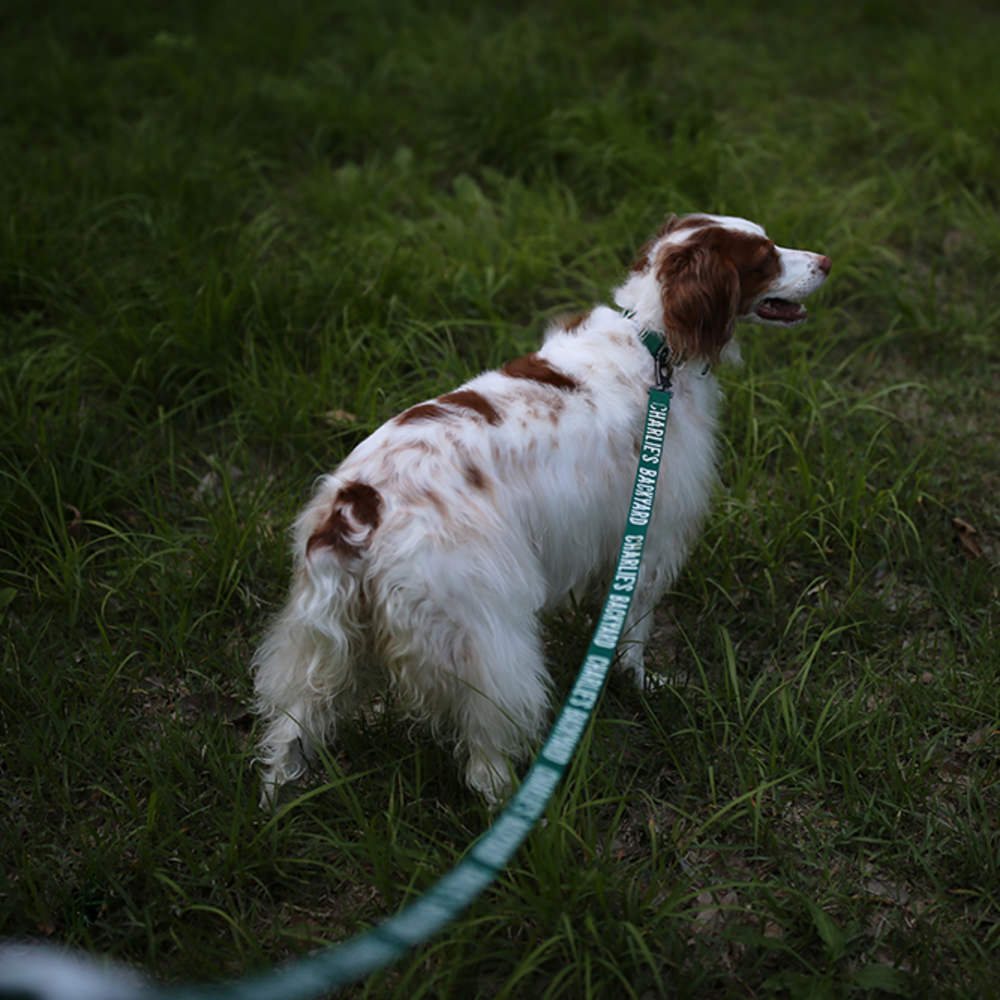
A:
656;238;740;361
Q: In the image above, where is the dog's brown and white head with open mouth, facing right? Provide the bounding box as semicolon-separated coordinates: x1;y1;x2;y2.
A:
615;215;831;361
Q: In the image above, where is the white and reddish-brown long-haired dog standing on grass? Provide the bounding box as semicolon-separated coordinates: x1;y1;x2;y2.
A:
253;215;831;805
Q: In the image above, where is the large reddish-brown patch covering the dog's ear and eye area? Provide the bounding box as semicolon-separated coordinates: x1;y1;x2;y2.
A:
656;225;780;361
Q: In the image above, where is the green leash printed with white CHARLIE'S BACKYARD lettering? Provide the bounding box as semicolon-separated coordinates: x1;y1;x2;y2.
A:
0;322;673;1000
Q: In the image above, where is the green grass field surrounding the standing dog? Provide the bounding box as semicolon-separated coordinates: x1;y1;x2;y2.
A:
0;0;1000;1000
